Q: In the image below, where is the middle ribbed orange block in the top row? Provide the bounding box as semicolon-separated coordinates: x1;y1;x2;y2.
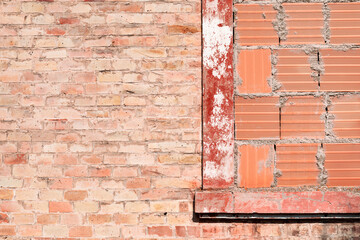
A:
281;3;325;44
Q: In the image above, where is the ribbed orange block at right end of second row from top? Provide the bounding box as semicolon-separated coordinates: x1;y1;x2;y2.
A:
320;48;360;92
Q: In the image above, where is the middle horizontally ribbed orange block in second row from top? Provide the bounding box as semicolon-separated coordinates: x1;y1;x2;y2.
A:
275;49;319;92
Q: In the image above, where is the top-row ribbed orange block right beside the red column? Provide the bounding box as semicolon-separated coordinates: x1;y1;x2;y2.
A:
234;4;279;46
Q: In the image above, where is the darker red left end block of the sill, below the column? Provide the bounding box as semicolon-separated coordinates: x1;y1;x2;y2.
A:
195;192;233;213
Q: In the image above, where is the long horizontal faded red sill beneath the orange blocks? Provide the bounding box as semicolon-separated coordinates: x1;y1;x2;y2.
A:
195;191;360;218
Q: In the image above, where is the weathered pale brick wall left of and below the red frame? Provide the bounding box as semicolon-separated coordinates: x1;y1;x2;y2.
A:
0;0;360;239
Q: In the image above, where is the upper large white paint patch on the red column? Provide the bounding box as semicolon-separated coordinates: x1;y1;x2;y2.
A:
203;0;232;79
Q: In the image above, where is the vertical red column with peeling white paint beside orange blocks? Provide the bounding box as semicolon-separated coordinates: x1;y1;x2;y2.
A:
202;0;234;189
